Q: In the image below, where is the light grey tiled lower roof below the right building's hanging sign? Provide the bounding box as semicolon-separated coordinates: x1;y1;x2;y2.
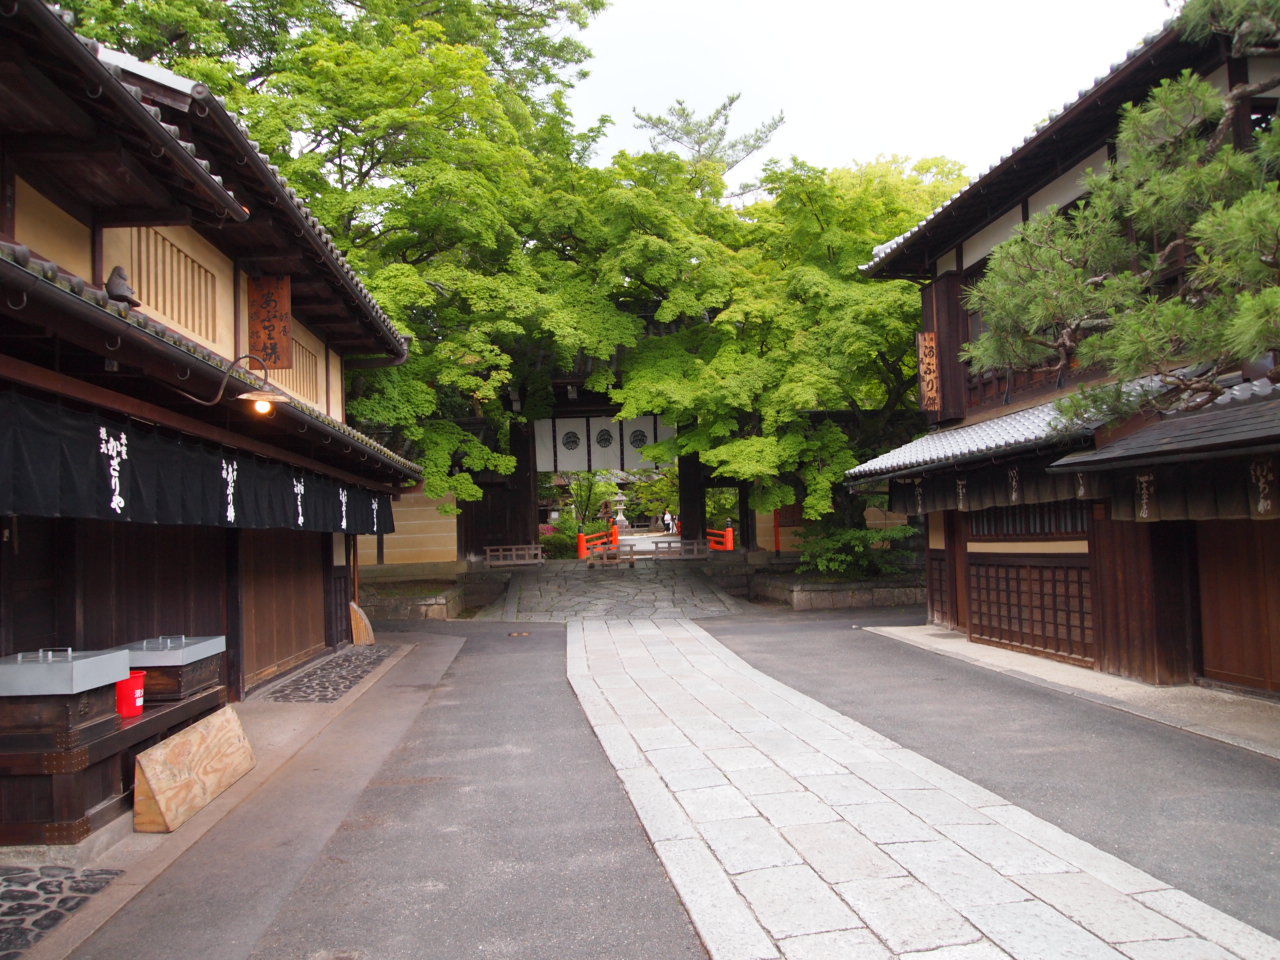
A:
846;402;1093;480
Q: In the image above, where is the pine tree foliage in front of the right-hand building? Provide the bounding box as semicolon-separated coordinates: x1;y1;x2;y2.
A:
965;0;1280;415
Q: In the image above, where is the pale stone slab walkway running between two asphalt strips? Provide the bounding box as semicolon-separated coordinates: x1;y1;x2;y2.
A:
566;617;1280;960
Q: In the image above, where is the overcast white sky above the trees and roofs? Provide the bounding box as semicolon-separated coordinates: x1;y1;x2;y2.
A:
570;0;1175;188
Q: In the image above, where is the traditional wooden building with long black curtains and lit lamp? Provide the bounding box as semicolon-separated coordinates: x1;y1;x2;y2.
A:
0;0;420;842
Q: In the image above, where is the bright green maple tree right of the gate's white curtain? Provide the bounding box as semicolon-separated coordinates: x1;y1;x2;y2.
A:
613;159;960;517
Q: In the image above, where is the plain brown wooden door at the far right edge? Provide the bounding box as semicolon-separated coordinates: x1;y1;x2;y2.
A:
1197;520;1280;690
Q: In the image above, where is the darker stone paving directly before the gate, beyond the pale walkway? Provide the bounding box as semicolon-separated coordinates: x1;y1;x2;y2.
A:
477;558;741;623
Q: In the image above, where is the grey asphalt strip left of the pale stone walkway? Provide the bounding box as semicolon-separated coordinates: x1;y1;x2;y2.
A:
72;622;707;960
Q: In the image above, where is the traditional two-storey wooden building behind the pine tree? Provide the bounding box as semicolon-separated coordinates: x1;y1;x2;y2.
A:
850;22;1280;691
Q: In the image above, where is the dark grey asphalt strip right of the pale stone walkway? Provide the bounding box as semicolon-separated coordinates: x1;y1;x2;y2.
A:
700;611;1280;937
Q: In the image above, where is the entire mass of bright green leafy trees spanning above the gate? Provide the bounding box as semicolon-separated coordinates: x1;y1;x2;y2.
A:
70;0;961;535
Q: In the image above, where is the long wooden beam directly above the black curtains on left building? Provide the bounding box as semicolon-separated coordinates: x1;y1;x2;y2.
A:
0;356;399;493
